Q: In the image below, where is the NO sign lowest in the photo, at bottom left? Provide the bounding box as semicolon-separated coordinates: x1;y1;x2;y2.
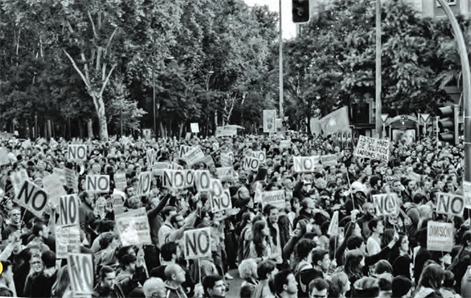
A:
67;253;95;295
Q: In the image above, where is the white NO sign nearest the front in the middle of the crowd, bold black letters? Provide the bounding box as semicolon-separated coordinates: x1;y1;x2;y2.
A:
183;227;211;260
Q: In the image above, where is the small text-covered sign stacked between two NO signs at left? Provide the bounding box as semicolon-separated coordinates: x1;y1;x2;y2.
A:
56;225;81;259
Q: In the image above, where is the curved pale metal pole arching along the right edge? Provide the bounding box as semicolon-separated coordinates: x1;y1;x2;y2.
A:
438;0;471;183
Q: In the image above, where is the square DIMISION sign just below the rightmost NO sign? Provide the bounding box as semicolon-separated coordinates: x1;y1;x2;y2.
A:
427;221;455;252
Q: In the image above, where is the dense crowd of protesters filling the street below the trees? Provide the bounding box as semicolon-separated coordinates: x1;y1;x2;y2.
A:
0;133;471;298
